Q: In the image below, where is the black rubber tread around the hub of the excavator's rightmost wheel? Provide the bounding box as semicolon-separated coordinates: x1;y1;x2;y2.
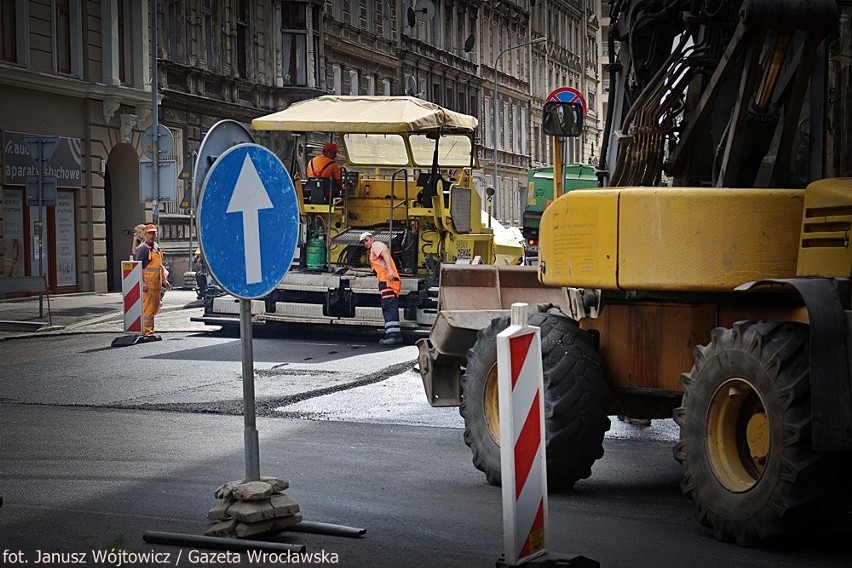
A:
674;321;845;546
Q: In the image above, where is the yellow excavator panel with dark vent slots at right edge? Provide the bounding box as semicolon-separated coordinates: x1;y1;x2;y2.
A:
796;177;852;278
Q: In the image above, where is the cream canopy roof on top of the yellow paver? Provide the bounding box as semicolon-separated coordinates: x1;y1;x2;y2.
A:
251;95;478;134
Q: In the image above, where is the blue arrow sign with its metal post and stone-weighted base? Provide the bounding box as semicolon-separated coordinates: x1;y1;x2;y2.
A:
151;141;365;550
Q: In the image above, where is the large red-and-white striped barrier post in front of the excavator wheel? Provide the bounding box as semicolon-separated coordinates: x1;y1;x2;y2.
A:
497;303;600;568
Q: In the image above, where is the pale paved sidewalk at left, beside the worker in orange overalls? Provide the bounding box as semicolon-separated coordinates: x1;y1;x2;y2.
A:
0;289;211;341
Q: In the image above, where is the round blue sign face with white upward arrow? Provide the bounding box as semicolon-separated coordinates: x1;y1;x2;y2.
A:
198;144;299;299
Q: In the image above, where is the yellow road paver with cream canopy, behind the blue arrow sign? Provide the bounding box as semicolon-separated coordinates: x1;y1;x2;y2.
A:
199;95;523;330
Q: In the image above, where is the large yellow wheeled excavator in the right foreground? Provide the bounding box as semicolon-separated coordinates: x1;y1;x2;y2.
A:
418;0;852;546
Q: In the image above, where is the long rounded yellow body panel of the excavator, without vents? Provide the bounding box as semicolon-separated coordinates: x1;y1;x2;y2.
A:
539;187;805;292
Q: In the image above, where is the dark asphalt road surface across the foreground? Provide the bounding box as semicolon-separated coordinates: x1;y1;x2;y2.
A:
0;326;852;568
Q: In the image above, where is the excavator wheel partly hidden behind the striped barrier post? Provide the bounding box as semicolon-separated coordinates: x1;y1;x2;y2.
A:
459;309;610;490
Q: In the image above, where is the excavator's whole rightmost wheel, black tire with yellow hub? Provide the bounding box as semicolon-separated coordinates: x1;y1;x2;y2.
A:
674;321;848;546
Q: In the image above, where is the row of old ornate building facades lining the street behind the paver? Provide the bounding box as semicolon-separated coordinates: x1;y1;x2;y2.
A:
0;0;601;293
